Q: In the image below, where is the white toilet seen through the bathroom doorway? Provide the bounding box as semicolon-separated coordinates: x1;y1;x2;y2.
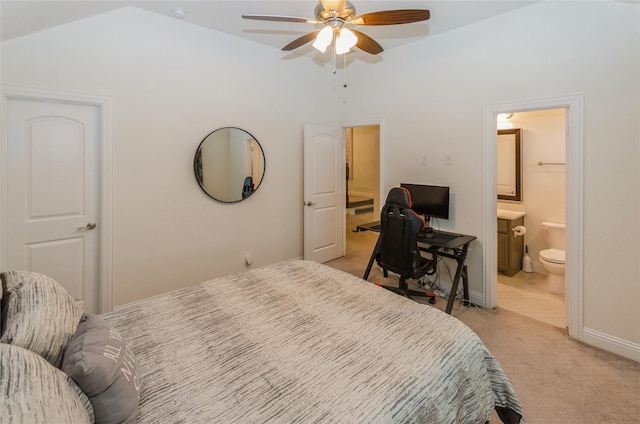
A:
538;222;565;294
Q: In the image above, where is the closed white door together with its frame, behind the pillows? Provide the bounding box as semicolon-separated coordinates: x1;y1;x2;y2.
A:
0;86;113;313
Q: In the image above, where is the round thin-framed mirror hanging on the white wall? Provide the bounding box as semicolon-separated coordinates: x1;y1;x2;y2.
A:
193;127;265;203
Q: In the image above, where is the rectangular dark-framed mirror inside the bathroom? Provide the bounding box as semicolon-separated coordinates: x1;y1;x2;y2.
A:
496;128;522;202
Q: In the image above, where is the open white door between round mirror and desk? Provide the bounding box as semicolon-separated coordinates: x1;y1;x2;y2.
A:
304;125;345;263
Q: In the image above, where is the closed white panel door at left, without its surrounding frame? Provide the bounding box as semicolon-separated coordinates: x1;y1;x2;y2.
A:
6;99;100;312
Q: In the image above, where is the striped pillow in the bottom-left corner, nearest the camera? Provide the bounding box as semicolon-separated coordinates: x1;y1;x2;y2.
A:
0;343;93;424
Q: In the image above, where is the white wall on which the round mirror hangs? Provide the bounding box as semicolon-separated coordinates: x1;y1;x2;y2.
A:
2;7;336;305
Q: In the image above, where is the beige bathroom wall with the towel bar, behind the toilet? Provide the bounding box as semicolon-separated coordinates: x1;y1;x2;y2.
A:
498;109;566;273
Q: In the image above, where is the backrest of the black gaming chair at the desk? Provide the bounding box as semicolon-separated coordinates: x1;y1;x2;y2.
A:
377;187;425;278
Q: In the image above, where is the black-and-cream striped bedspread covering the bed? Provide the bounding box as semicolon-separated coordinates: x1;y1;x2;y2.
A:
105;261;524;424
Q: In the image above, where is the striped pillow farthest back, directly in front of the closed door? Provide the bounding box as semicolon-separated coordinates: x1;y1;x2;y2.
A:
0;271;82;368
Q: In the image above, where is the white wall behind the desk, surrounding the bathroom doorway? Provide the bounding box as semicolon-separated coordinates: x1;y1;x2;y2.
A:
341;1;640;357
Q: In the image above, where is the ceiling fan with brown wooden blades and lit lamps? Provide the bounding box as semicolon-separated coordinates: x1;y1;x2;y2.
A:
242;0;430;54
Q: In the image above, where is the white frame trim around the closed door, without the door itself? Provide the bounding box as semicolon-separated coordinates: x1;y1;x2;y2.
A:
0;85;113;313
